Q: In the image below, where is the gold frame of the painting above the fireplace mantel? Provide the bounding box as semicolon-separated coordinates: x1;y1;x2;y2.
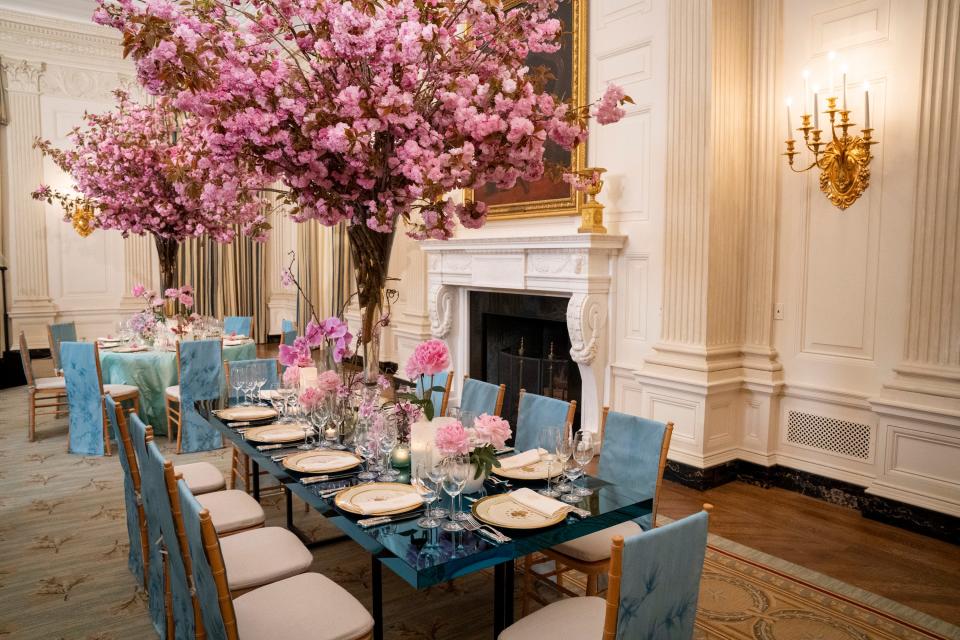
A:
464;0;588;220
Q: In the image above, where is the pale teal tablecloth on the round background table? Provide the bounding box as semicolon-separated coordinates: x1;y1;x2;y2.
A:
100;342;257;435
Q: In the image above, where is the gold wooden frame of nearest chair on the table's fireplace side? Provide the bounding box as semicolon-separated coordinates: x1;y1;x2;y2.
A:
522;407;673;615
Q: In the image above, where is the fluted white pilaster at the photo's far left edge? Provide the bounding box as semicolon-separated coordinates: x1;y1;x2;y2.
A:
2;60;56;347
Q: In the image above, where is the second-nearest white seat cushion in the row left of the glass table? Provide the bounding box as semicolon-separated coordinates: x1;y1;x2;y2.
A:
220;527;313;591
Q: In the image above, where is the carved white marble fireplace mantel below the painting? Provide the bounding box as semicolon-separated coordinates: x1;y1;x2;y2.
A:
420;234;627;431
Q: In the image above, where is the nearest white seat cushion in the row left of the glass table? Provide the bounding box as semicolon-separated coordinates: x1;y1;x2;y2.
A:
233;573;376;640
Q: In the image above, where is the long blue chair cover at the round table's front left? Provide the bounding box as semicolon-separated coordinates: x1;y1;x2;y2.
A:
60;342;104;456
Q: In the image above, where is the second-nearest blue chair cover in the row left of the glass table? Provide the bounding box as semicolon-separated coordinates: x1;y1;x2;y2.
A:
140;430;195;638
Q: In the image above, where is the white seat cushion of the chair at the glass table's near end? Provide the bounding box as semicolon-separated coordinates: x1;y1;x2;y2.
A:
498;597;607;640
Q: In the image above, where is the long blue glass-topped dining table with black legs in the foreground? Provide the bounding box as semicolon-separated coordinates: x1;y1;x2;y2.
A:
197;401;653;640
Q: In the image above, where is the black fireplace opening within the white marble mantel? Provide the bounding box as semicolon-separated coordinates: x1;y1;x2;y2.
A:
470;291;581;429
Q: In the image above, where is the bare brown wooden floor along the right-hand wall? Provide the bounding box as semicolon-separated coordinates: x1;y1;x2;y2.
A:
660;481;960;625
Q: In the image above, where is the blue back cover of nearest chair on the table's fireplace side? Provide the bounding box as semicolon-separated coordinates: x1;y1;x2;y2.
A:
597;411;667;529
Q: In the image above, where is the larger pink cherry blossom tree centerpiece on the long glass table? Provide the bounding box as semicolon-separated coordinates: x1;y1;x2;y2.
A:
94;0;629;377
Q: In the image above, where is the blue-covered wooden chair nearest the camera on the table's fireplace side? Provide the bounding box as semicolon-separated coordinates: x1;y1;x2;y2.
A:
522;407;673;612
